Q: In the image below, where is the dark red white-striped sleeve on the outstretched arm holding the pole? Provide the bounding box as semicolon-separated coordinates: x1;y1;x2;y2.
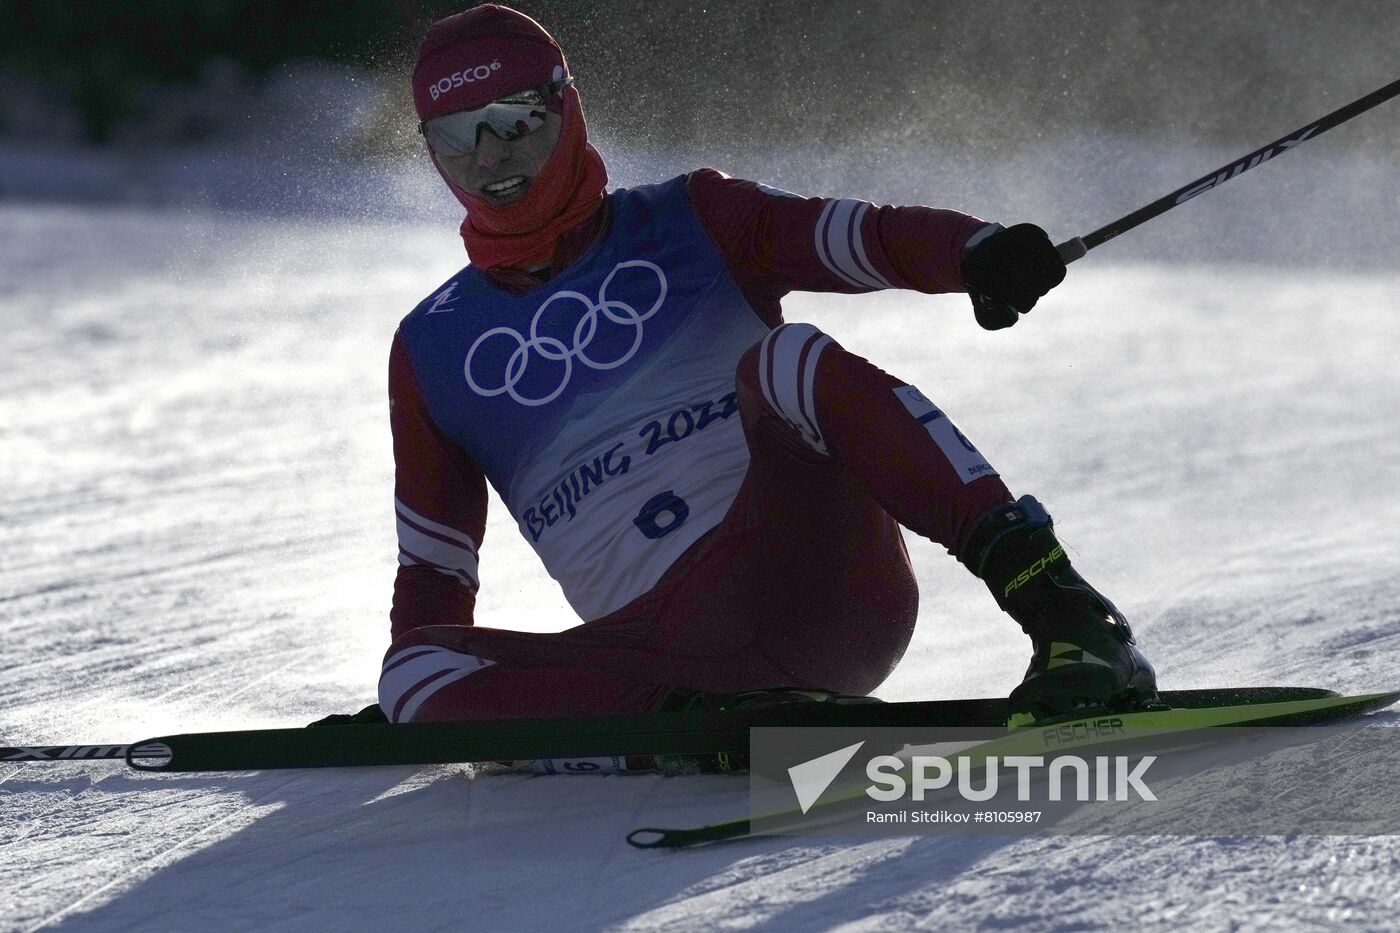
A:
686;168;987;326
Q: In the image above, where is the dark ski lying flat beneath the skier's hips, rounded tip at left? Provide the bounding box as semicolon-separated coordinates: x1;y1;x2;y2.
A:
0;686;1377;772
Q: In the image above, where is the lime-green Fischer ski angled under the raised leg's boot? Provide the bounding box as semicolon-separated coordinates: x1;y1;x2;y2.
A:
627;688;1400;849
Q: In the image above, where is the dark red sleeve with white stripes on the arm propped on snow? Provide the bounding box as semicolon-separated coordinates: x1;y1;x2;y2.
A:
389;333;486;637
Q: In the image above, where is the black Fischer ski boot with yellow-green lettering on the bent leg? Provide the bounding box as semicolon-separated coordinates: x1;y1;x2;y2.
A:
959;496;1159;726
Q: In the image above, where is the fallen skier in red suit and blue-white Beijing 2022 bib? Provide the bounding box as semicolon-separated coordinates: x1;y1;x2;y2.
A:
379;4;1156;723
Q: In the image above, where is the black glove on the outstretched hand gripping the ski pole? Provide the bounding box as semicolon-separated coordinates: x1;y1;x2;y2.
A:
962;224;1064;331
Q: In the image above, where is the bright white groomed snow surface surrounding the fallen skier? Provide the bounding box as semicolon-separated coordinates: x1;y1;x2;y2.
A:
0;206;1400;932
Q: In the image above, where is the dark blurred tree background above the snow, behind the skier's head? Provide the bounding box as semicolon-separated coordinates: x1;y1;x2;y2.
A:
0;0;1400;153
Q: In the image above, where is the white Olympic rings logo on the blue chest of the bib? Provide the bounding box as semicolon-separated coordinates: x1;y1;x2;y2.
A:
462;259;666;408
